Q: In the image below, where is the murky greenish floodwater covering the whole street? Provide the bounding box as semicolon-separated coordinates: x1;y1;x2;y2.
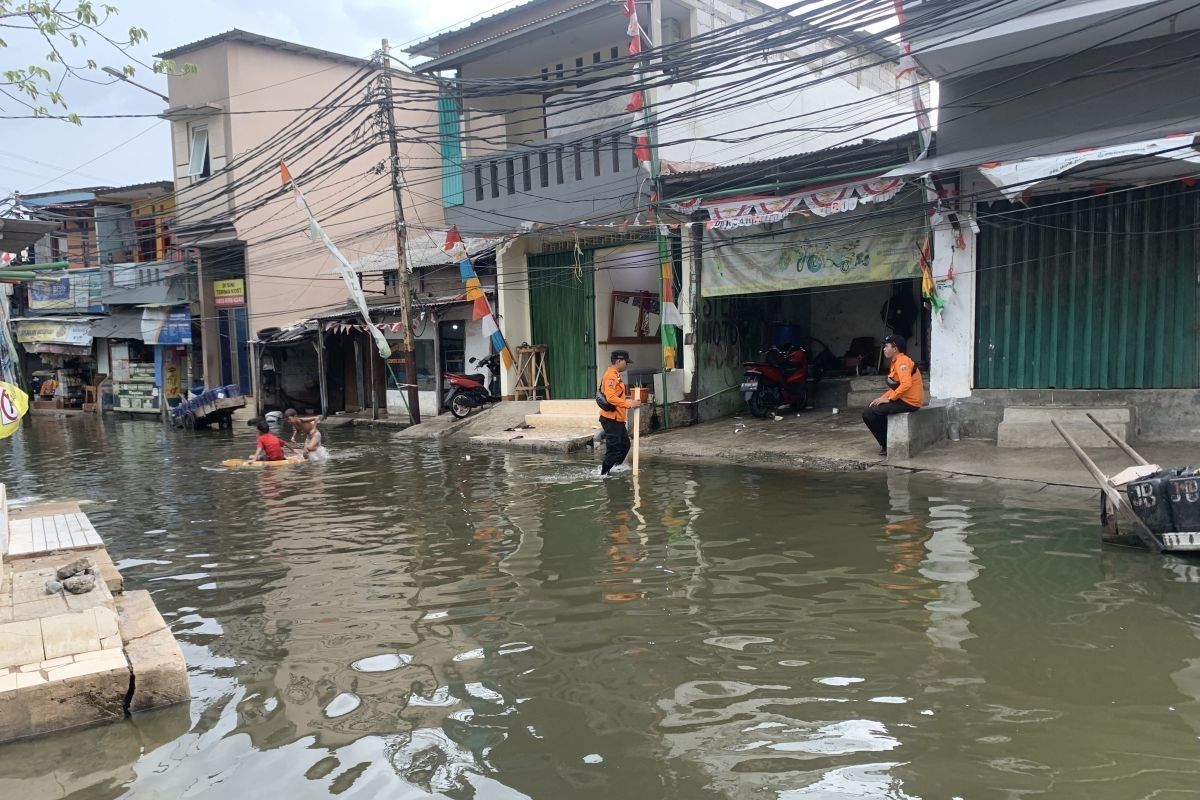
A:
0;419;1200;800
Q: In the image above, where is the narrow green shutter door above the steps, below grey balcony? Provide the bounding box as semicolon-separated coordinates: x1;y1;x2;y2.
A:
528;251;596;399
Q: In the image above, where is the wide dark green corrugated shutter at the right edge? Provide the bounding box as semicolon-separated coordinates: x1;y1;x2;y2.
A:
976;182;1200;389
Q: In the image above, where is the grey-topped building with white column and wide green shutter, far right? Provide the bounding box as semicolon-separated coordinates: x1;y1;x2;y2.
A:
894;0;1200;444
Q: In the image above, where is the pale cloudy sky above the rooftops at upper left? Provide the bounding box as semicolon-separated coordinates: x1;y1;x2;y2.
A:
0;0;517;198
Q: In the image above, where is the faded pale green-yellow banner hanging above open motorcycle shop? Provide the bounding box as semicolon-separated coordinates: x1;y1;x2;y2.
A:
701;203;925;297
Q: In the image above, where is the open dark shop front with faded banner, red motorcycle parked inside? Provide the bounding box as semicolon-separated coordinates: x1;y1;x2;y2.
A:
695;193;929;420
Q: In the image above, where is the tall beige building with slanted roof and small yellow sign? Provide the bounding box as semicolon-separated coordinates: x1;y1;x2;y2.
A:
160;30;442;410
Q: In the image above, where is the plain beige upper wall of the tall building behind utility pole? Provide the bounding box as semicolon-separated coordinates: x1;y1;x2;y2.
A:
168;41;443;386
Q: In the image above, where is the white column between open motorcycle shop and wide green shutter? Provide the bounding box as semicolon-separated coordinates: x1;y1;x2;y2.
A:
929;191;977;399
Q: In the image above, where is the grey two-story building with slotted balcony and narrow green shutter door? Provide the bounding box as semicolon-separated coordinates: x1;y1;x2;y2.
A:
409;0;914;398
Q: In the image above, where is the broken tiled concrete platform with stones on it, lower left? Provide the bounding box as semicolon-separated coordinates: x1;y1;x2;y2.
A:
0;486;191;741
